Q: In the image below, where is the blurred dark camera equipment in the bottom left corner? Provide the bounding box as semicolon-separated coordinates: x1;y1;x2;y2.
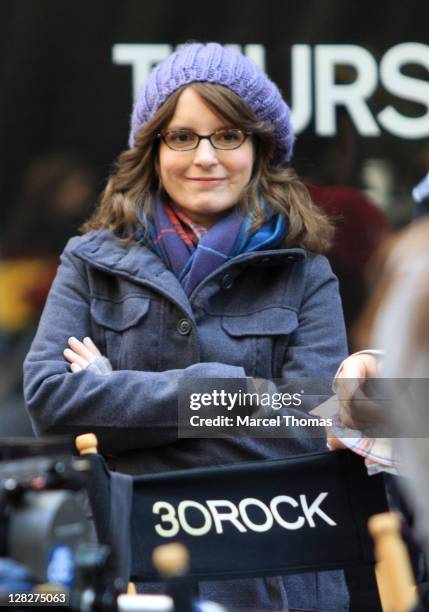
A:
0;437;124;612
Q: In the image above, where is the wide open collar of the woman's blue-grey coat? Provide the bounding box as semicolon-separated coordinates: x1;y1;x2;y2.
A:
72;230;307;313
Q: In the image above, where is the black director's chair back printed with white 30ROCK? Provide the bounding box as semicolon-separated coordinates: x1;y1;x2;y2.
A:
76;434;387;604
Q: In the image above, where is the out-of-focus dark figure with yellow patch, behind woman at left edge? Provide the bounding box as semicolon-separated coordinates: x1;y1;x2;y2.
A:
0;154;94;436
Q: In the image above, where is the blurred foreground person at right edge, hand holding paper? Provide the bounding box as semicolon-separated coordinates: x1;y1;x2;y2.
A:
329;219;429;600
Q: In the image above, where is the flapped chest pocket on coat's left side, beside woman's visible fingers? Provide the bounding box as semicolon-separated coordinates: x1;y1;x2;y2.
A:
91;295;150;370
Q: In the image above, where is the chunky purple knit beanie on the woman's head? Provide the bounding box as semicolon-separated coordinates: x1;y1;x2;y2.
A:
129;43;295;163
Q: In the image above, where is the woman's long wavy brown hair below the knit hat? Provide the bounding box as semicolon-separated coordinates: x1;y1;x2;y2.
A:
81;83;334;253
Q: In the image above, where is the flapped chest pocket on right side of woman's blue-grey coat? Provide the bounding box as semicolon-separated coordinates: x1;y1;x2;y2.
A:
222;307;298;378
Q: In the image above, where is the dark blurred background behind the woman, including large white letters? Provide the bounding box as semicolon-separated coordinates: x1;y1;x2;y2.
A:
0;0;429;435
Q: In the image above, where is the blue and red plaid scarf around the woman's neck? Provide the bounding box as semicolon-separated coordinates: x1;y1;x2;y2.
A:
137;201;287;296
